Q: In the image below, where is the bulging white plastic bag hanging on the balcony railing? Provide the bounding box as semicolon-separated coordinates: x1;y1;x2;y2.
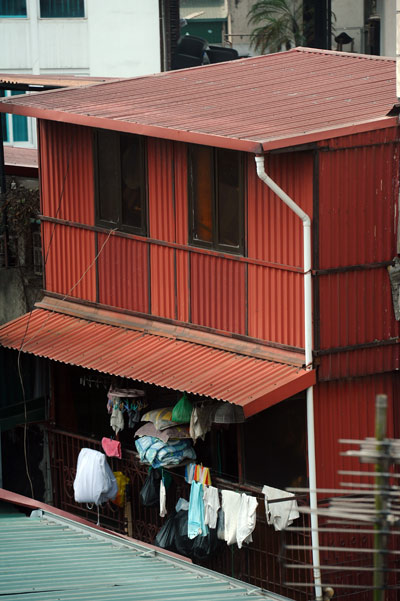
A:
74;449;118;505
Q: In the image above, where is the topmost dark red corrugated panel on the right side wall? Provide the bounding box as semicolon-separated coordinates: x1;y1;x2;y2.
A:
319;134;399;269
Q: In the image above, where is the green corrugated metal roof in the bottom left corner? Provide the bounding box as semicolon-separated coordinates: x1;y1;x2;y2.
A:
0;492;294;601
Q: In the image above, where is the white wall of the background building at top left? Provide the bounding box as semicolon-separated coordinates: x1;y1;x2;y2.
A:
0;0;160;77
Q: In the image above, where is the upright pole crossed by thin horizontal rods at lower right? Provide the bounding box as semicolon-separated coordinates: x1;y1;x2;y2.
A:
374;394;389;601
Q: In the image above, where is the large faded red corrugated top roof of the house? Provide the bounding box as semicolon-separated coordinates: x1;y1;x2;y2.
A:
0;48;397;152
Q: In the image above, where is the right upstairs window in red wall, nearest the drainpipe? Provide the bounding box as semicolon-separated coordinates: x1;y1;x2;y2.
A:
189;145;244;254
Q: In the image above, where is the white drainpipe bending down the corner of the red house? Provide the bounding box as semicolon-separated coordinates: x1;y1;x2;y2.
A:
255;155;322;600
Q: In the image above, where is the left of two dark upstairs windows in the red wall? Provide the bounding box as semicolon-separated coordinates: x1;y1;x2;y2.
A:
95;130;146;235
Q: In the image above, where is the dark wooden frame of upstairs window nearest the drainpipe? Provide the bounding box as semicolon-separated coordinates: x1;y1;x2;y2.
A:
188;144;246;256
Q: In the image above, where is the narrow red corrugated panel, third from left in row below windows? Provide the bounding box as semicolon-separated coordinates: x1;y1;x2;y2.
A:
150;244;176;319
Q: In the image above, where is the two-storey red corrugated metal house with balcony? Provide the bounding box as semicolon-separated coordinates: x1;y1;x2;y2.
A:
0;49;400;599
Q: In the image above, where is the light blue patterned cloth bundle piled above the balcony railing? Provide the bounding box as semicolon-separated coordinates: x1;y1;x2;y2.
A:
135;436;196;468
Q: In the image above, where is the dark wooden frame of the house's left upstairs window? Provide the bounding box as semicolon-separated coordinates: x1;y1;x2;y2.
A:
93;130;148;237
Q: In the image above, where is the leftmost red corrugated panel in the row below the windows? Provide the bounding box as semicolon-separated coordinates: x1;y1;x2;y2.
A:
42;222;96;301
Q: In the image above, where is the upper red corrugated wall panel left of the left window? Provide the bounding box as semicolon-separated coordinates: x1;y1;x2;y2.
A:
39;121;94;225
